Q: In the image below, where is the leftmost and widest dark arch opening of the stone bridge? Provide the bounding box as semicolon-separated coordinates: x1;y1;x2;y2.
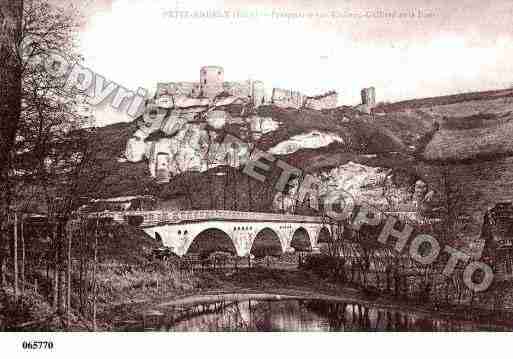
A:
186;228;237;257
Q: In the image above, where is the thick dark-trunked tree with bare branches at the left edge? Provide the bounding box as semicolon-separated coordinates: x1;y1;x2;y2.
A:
0;0;82;306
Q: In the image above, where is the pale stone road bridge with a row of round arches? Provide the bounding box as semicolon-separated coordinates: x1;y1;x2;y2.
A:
97;210;332;257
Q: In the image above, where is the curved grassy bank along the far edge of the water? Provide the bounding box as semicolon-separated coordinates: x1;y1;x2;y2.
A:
104;268;513;330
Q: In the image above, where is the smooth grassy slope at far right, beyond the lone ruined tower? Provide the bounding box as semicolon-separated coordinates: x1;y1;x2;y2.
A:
384;90;513;161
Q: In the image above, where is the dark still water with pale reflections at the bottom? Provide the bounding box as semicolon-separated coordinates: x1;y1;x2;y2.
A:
133;300;505;331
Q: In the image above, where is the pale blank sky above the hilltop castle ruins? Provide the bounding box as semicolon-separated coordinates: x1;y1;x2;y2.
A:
71;0;513;124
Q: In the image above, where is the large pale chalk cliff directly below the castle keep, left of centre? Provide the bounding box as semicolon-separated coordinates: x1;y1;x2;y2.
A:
125;105;250;182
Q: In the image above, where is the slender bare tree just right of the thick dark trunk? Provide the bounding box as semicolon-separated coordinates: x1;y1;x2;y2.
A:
15;0;83;313
